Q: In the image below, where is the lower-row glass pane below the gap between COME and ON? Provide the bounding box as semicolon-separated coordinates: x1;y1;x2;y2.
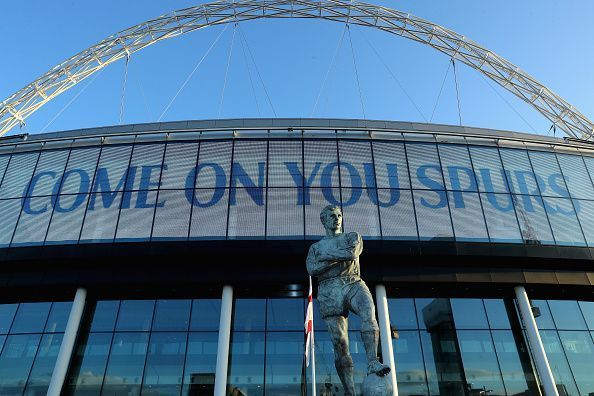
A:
152;190;193;240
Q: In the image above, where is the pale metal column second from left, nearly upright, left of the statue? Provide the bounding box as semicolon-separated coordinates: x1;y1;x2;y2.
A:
214;286;233;396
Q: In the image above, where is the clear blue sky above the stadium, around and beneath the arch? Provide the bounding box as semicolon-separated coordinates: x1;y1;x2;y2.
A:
0;0;594;135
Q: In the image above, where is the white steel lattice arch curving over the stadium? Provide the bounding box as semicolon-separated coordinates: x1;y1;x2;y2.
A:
0;0;594;140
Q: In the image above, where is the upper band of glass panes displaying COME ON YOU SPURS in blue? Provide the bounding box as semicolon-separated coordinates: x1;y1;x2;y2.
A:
0;130;594;247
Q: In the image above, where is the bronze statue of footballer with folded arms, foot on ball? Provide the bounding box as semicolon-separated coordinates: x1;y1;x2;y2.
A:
307;205;390;396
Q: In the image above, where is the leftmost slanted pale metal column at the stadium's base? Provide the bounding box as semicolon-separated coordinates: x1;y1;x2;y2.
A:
47;288;87;396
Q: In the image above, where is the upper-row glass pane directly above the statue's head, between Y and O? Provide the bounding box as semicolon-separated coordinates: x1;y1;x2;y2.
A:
303;140;340;188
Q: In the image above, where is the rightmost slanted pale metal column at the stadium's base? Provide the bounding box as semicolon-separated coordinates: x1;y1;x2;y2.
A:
514;286;559;396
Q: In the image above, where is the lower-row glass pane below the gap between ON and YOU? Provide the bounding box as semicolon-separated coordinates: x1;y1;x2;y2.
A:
266;188;304;239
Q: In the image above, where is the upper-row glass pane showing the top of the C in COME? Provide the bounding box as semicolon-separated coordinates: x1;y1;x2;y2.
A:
27;150;70;196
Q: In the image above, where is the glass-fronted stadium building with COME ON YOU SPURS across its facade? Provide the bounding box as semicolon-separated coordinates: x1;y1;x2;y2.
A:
0;119;594;395
